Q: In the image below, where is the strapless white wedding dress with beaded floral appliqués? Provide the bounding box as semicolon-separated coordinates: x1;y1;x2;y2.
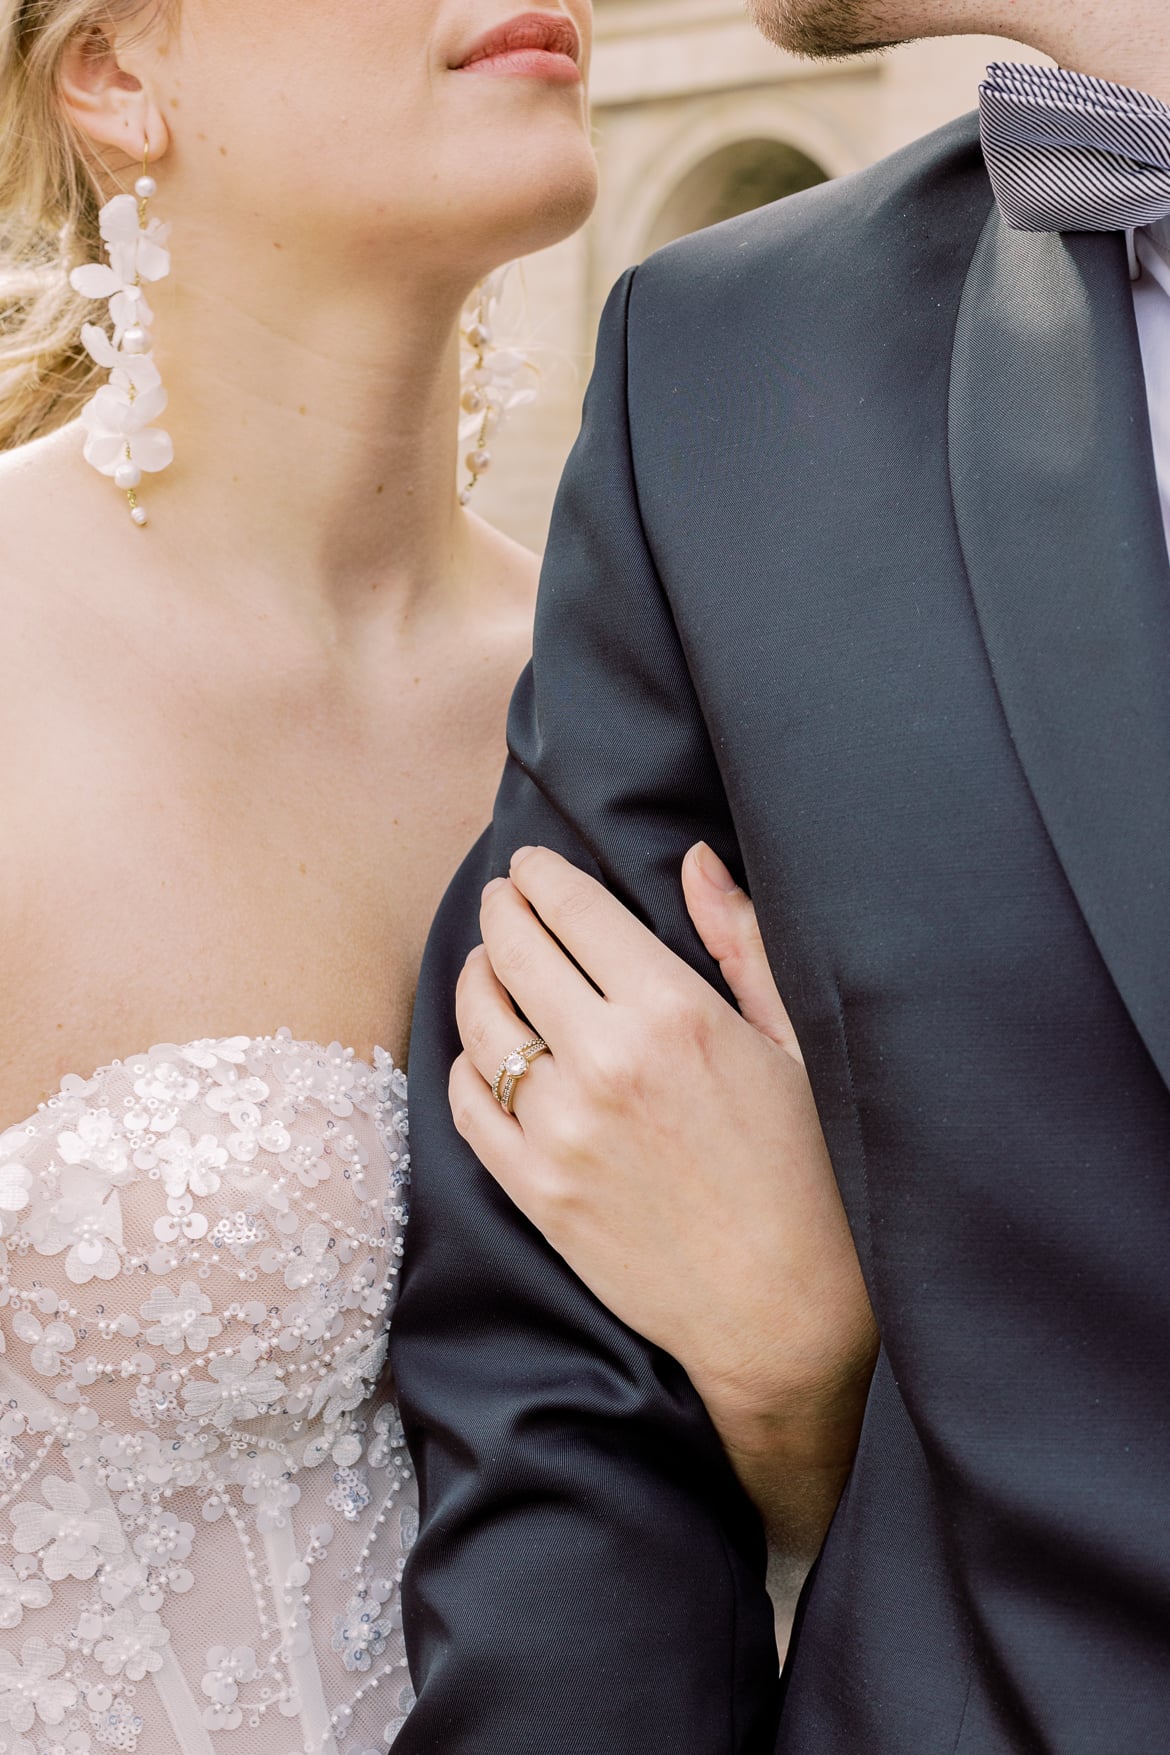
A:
0;1032;417;1755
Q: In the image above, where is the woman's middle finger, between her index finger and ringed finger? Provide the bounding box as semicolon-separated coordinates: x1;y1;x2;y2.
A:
479;878;605;1045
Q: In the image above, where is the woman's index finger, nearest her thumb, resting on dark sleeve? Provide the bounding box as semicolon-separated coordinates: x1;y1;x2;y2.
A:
505;848;679;1006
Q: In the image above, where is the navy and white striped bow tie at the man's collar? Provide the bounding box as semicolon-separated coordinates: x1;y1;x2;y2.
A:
979;63;1170;232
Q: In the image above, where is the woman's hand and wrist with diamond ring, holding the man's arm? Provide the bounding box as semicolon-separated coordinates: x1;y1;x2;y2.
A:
451;846;875;1565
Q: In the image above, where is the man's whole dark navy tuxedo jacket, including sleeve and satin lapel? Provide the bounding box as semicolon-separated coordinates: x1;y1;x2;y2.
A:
393;118;1170;1755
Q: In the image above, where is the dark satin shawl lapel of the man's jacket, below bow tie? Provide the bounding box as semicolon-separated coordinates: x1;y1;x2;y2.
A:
951;209;1170;1083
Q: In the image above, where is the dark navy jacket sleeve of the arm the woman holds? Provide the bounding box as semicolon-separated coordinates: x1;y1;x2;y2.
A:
393;263;777;1755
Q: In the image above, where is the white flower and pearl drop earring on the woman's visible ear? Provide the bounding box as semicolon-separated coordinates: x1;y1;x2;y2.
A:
70;144;175;527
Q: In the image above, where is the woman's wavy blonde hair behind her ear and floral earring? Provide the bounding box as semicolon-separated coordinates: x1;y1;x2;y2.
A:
0;0;174;451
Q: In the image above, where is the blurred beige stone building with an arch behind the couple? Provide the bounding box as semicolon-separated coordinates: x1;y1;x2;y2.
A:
475;15;1040;549
